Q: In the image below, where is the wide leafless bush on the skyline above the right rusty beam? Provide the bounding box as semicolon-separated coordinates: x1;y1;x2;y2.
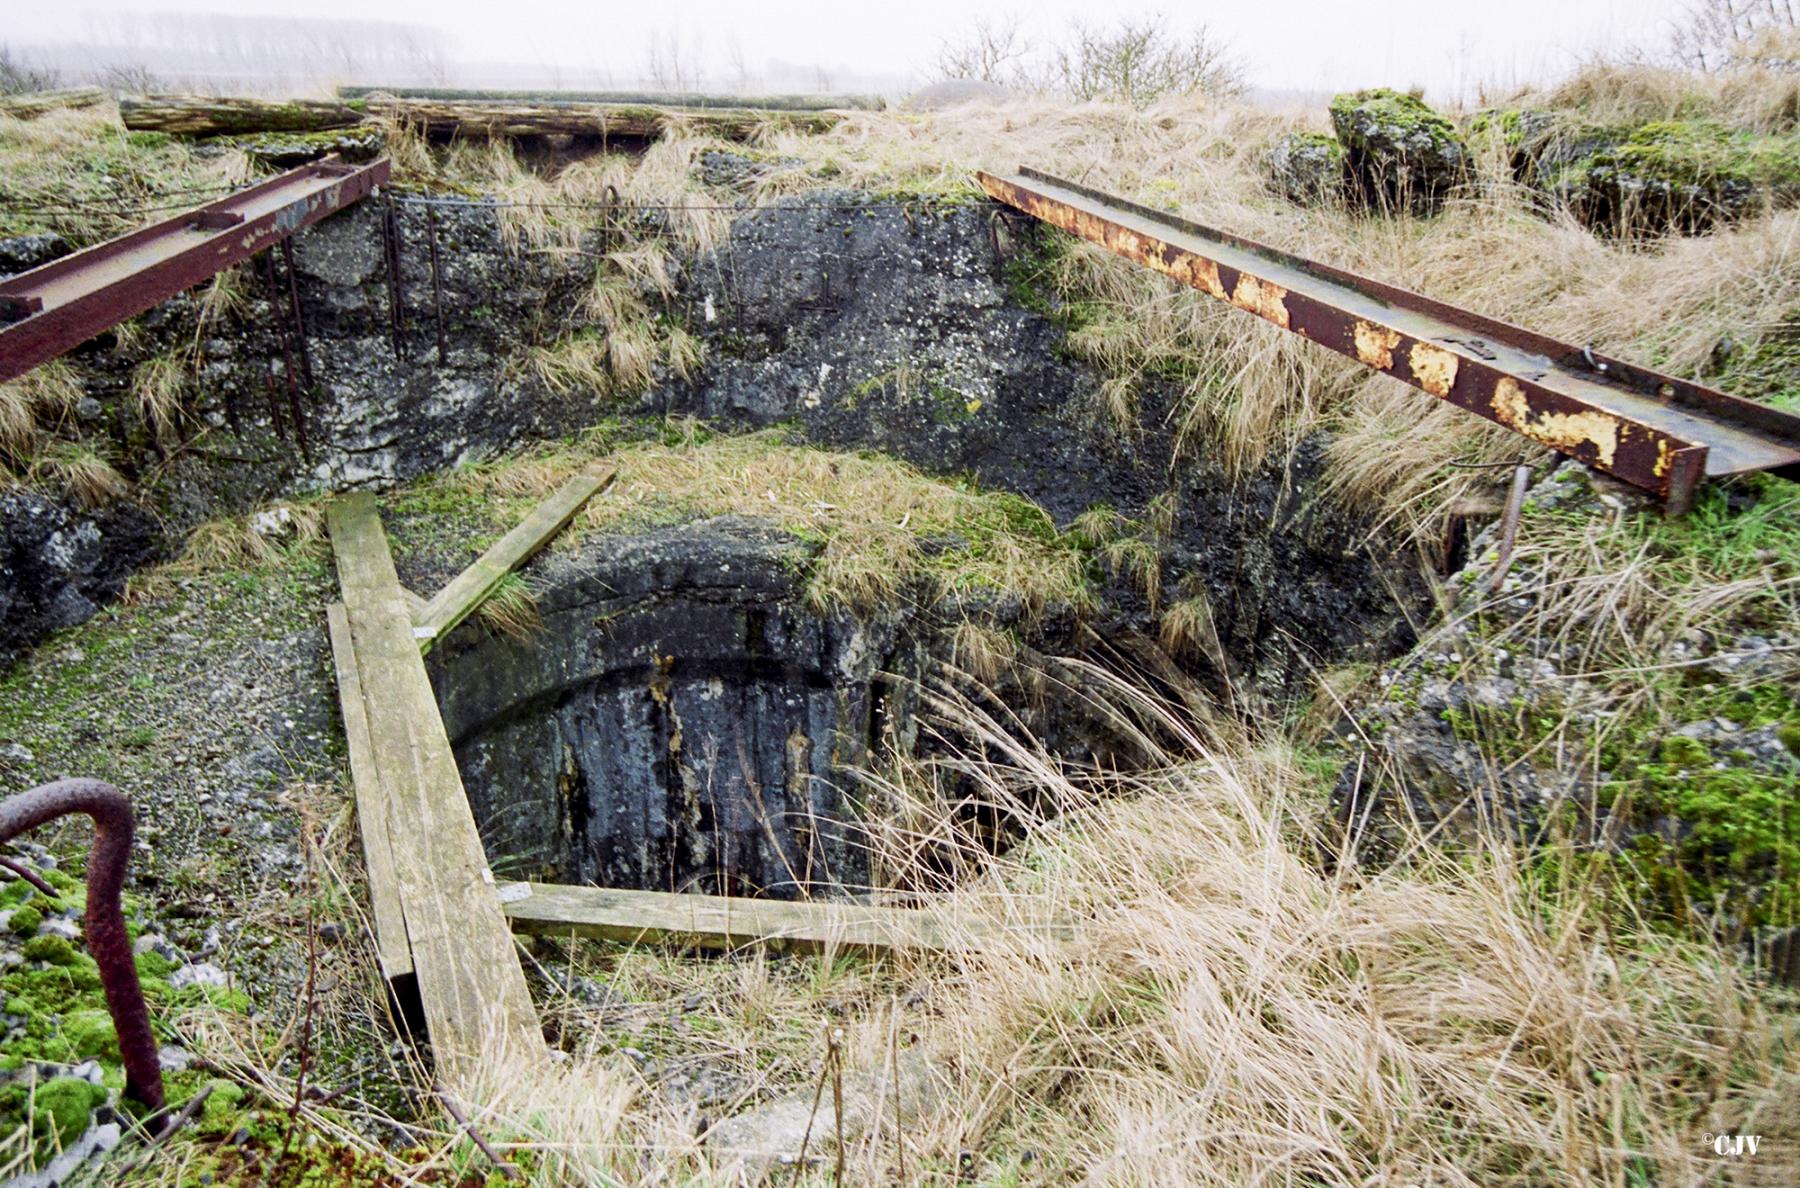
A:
1055;14;1244;106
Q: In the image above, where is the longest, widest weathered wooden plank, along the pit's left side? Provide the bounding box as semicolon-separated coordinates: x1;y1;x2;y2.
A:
326;495;547;1080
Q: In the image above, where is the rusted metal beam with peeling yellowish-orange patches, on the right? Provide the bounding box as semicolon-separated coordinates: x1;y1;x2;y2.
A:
977;169;1800;511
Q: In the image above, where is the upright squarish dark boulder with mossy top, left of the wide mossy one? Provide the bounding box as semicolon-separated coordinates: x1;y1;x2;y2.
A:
1332;88;1471;214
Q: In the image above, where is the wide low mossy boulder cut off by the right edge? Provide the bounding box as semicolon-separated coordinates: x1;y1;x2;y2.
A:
1546;121;1800;234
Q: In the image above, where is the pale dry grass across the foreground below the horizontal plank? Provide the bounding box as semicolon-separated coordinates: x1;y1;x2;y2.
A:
324;671;1800;1186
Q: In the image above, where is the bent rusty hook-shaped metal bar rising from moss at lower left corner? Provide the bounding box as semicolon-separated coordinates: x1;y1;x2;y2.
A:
0;779;164;1111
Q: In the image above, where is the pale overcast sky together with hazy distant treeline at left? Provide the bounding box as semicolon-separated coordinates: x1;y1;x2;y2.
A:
0;0;1683;101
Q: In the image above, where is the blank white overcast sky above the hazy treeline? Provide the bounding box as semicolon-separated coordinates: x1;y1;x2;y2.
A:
0;0;1687;97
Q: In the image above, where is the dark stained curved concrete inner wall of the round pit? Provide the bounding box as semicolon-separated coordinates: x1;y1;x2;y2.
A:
430;517;922;898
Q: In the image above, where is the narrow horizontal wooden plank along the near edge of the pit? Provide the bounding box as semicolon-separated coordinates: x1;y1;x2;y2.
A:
500;882;1075;952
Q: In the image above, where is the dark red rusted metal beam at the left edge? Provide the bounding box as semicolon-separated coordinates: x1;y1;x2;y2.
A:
0;158;389;380
